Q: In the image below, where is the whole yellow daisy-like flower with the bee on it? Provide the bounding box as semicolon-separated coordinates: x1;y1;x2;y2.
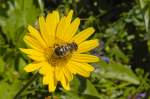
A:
20;10;99;92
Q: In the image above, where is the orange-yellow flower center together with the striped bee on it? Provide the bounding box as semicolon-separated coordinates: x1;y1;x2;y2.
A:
45;38;78;66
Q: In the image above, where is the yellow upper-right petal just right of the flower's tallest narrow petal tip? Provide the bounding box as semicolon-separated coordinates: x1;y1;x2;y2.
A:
64;18;80;42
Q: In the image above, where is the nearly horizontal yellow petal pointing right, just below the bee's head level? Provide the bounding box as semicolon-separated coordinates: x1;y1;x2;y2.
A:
71;54;99;63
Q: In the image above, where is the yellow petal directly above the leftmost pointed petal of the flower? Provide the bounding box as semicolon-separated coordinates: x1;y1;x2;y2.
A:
24;35;44;52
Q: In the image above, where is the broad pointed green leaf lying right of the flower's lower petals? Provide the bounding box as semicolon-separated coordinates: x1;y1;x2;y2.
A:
99;61;139;84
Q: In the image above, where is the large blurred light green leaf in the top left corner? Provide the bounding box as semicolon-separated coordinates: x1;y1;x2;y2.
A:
0;0;40;45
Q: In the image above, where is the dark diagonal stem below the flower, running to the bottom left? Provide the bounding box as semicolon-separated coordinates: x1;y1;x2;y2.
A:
13;72;39;99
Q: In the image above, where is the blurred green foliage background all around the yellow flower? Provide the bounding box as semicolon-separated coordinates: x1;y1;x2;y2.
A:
0;0;150;99
